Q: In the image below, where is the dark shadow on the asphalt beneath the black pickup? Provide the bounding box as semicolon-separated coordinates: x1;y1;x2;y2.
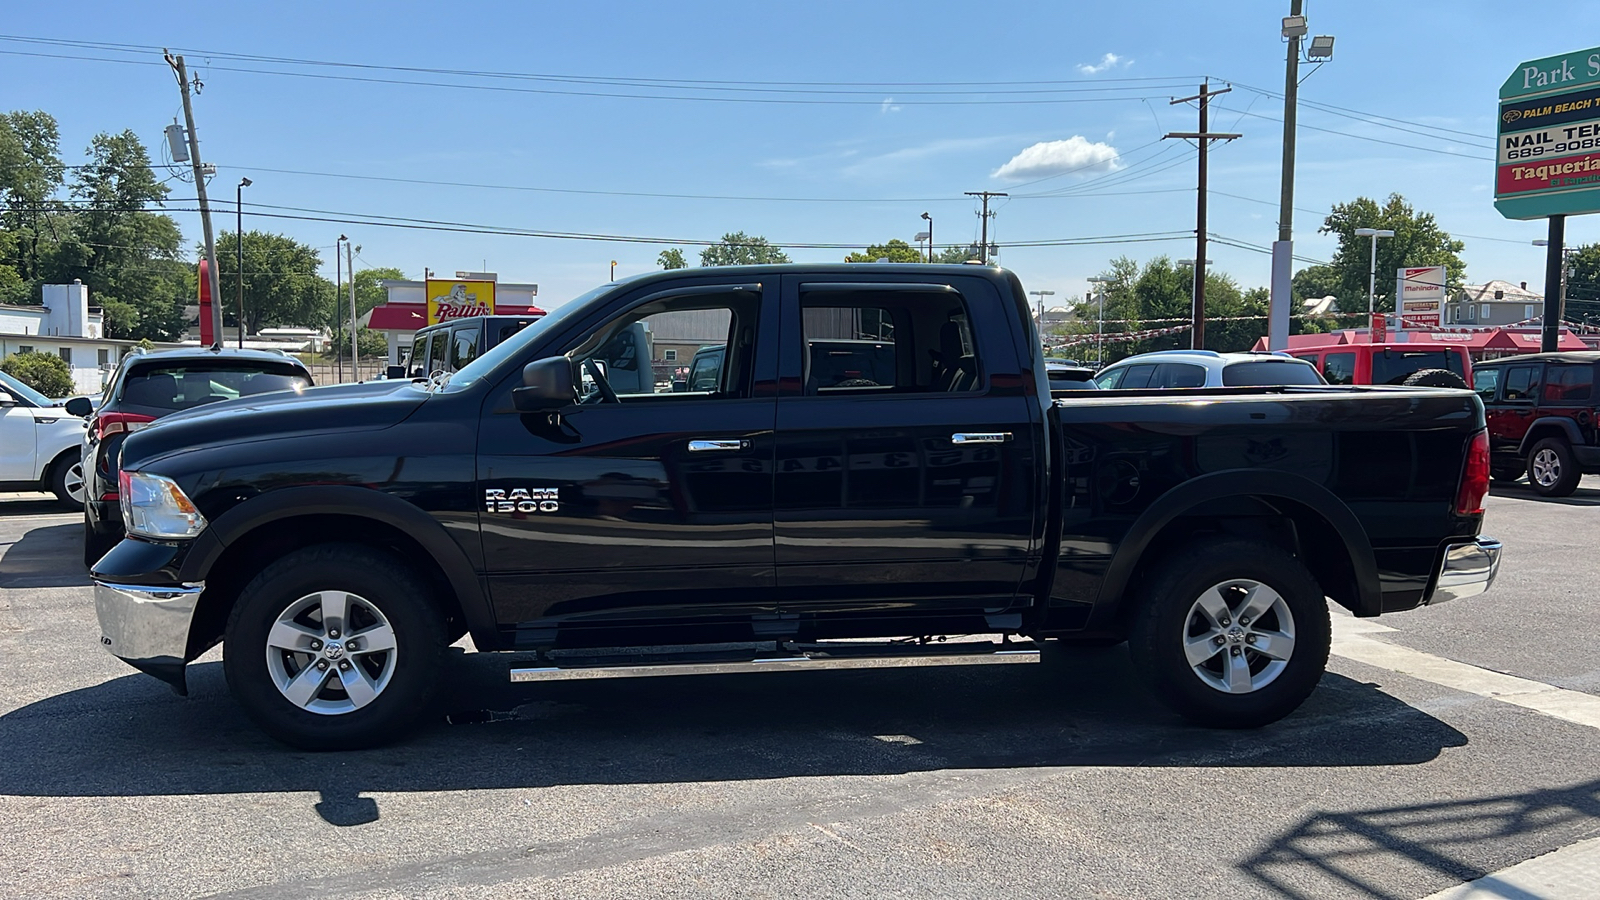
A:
0;649;1467;825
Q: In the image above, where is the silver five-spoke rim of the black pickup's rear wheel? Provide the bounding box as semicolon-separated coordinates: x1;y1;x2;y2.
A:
1182;578;1294;693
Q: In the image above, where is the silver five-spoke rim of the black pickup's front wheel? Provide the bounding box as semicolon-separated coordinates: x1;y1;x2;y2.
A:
267;591;400;716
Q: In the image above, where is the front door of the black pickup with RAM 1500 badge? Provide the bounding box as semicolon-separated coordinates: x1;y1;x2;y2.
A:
478;285;776;628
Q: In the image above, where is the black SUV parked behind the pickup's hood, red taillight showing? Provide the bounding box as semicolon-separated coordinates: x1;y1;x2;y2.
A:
66;348;312;565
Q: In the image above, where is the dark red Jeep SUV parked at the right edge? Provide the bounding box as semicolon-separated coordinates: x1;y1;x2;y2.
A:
1472;351;1600;496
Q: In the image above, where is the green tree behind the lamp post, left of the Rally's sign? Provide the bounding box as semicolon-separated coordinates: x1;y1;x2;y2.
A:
216;231;331;335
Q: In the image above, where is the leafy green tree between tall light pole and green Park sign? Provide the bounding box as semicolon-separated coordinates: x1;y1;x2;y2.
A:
1314;194;1467;312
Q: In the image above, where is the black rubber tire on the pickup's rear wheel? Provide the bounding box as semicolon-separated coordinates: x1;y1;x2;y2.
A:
1128;538;1331;729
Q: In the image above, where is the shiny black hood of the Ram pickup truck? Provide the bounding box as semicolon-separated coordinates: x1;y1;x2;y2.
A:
122;381;429;468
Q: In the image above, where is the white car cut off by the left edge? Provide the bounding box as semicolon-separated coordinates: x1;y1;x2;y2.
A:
0;365;83;509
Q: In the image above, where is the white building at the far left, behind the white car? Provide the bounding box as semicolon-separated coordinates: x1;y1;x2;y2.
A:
0;282;138;394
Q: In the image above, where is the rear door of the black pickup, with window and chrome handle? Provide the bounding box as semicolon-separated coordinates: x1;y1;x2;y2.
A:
774;269;1043;613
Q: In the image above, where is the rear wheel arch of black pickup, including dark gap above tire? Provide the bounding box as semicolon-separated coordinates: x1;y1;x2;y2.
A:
1093;469;1382;625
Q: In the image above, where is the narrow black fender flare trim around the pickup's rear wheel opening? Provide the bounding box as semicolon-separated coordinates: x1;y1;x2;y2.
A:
1094;469;1382;618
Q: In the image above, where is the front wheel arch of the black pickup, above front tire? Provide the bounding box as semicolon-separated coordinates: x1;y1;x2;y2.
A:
179;485;498;658
